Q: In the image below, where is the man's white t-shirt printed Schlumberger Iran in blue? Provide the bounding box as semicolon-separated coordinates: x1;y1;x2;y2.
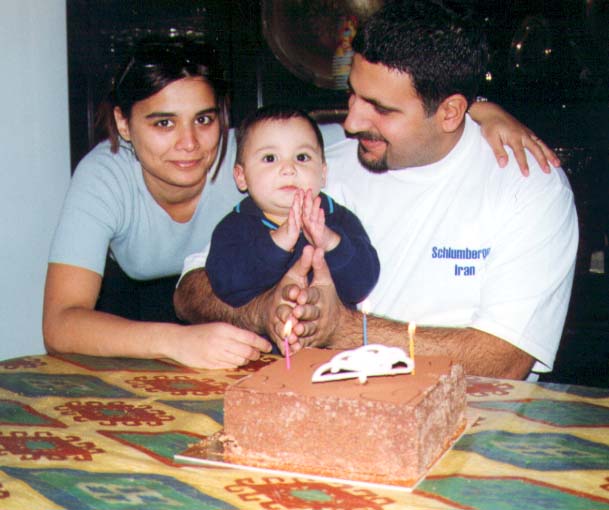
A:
324;117;578;372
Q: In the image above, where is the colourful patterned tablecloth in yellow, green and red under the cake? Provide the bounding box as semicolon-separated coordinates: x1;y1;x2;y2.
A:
0;356;609;510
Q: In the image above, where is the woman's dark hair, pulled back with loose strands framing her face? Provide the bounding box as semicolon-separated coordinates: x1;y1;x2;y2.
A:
98;38;230;180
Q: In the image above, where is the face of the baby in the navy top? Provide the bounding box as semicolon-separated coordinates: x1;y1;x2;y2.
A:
234;117;326;219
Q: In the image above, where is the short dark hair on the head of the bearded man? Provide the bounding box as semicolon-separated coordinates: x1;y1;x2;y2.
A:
353;0;488;115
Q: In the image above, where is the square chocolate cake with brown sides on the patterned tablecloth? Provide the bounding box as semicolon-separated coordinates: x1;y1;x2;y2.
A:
224;349;466;484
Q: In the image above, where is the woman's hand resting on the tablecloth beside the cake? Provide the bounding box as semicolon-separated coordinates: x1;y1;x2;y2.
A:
163;322;272;369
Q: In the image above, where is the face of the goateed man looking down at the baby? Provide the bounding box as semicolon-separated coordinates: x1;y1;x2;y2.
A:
344;54;445;172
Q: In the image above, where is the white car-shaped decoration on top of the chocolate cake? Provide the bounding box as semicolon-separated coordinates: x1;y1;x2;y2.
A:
311;344;414;384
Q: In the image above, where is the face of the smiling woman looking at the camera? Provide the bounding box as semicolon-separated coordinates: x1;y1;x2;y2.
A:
114;78;220;201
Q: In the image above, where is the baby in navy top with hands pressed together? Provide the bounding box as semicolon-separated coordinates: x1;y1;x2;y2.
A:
206;106;380;308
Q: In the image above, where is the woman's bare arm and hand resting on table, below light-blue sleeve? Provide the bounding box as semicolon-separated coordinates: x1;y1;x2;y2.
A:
43;264;271;368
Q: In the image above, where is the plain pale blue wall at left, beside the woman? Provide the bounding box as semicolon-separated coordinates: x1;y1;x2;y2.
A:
0;0;70;359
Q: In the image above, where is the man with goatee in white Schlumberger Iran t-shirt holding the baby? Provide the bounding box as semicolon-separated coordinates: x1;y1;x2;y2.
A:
176;2;578;378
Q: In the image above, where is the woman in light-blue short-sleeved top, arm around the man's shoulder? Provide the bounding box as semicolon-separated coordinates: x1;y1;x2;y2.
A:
43;37;546;368
